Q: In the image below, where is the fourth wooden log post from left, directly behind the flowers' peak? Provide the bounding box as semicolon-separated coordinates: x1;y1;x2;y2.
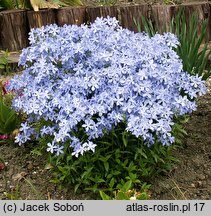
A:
86;6;118;22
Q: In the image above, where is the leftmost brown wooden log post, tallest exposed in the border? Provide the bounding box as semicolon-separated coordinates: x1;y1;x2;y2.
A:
0;10;29;51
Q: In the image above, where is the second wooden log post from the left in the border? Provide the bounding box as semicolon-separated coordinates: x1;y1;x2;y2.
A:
27;9;56;29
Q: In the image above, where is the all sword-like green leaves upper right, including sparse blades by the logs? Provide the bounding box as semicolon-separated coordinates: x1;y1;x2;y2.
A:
134;10;211;80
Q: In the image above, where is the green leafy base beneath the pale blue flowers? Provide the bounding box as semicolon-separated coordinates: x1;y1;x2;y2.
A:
40;118;180;197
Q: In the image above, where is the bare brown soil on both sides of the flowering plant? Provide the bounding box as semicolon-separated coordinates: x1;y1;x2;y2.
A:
0;75;211;200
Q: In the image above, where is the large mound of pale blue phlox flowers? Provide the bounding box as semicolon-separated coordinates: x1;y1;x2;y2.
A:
9;17;205;156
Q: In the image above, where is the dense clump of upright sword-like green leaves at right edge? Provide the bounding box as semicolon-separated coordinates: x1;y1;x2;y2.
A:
172;12;211;79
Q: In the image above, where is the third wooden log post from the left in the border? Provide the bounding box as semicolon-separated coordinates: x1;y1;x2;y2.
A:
56;7;86;26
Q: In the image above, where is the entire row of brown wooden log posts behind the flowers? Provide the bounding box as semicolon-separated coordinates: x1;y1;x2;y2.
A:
0;2;211;51
